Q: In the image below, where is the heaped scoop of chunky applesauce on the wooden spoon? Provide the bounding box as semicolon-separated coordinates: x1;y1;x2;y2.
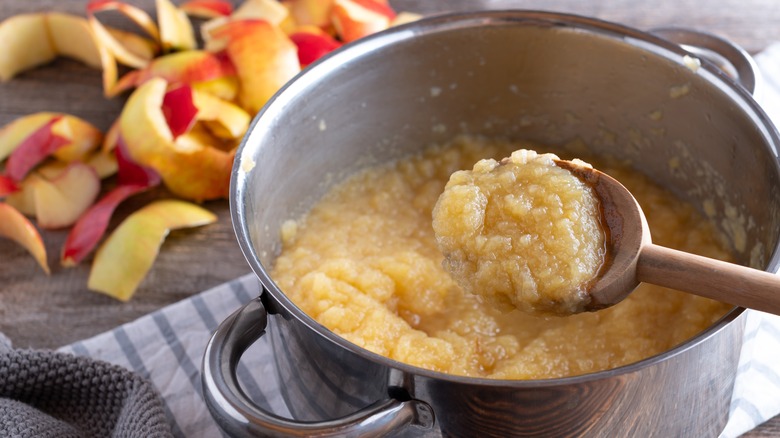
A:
433;149;606;316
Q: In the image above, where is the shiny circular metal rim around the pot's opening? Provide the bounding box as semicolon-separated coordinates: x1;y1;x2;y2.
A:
230;10;780;389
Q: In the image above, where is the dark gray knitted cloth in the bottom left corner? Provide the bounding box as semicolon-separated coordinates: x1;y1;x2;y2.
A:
0;339;172;438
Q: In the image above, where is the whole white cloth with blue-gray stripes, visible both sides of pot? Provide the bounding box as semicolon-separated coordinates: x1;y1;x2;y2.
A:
60;43;780;438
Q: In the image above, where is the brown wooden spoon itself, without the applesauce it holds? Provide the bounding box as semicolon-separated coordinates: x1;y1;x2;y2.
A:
556;160;780;315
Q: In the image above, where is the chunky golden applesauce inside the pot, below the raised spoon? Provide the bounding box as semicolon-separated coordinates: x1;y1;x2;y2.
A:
271;137;731;379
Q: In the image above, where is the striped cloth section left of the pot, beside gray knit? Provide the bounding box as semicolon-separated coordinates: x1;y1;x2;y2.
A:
59;274;289;438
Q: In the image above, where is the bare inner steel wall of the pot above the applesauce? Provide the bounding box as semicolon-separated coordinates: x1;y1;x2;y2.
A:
231;12;780;346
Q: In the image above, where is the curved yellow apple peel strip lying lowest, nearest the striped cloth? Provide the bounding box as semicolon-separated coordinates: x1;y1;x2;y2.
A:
87;200;217;302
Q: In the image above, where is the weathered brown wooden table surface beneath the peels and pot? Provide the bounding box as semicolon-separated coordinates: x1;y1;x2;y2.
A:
0;0;780;437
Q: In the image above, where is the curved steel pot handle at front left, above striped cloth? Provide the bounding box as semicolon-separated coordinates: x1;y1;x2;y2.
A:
202;297;433;437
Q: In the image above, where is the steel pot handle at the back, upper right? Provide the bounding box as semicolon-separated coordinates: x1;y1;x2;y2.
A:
650;27;760;96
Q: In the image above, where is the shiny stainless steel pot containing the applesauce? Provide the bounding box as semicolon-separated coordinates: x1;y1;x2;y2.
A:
204;12;780;436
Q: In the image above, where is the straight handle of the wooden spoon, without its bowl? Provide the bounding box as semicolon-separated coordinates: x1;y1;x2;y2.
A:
637;244;780;315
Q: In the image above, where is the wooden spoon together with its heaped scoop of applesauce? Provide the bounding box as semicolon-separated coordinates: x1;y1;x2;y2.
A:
433;150;780;316
